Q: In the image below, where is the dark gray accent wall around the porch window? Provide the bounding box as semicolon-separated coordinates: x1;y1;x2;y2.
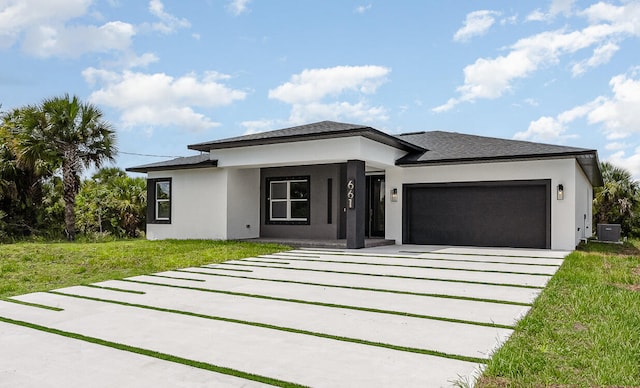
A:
260;164;344;240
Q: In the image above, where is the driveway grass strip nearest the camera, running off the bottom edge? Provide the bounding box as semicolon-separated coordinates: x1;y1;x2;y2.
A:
0;316;305;388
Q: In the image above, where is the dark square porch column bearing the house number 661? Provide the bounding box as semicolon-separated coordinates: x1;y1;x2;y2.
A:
346;160;367;249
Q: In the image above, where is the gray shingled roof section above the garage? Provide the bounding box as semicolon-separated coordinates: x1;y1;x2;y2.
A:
396;131;602;186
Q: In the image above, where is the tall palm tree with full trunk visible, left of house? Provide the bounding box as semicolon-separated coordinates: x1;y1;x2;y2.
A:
18;94;117;241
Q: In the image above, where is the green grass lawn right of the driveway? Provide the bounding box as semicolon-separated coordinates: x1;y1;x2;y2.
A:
477;241;640;387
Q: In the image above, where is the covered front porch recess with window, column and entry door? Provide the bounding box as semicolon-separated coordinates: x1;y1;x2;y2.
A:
251;160;386;248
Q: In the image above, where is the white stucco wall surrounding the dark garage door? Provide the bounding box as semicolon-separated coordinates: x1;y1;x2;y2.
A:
385;158;588;250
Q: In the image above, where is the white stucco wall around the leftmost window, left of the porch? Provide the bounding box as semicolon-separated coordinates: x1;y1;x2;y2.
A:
147;168;228;240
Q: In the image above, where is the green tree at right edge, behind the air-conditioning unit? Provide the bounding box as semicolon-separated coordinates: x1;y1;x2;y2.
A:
593;162;640;235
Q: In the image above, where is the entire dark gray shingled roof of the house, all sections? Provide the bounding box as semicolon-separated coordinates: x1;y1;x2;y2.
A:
127;121;602;186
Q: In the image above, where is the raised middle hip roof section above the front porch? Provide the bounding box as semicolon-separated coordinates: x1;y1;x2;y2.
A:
188;121;424;152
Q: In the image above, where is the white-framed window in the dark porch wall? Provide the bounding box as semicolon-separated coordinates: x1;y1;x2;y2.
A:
267;177;309;224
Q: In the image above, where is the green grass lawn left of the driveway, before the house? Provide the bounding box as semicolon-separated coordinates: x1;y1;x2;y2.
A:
0;240;289;298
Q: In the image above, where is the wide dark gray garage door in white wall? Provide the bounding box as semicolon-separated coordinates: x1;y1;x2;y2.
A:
403;180;551;249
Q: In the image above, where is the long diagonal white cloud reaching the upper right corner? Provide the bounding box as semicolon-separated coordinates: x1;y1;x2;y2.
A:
433;2;640;112
